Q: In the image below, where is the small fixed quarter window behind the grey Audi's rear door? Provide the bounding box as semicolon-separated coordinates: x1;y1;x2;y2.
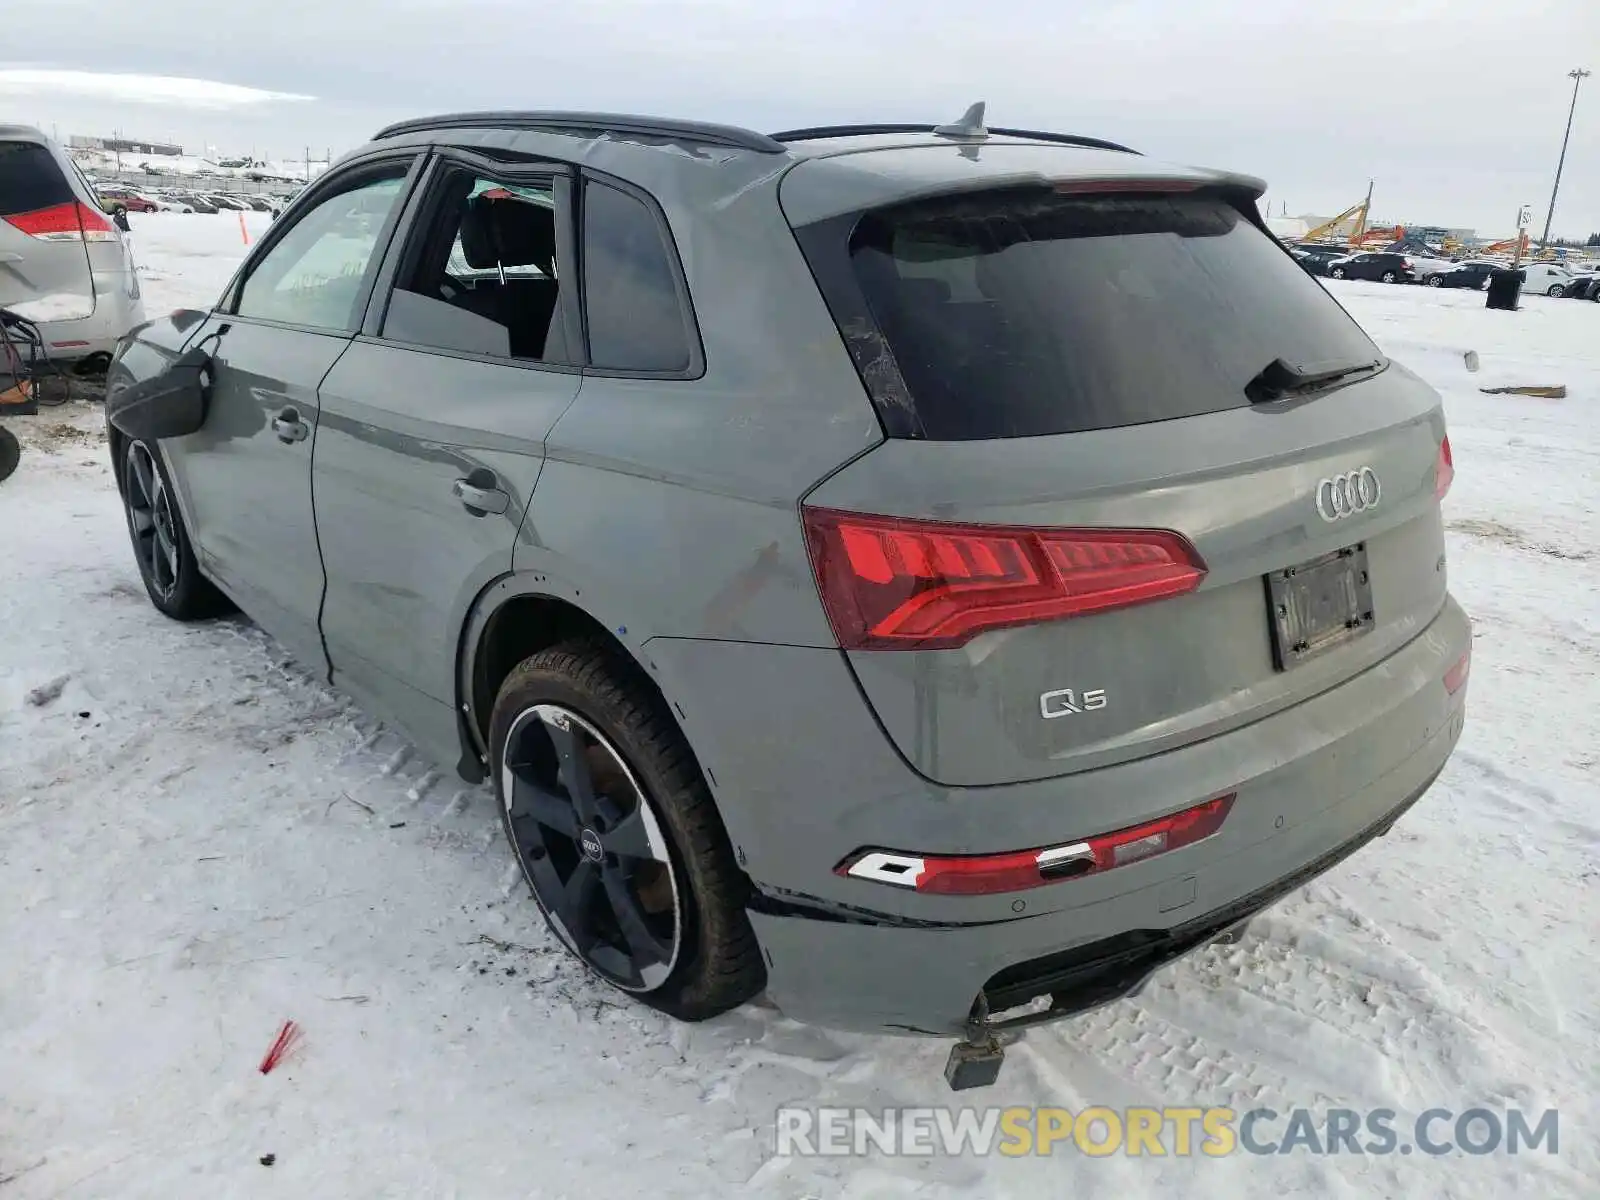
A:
582;181;691;371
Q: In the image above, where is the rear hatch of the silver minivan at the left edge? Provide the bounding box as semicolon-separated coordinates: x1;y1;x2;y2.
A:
0;131;102;322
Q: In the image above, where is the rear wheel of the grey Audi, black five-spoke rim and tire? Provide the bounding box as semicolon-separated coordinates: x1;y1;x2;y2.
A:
490;637;766;1021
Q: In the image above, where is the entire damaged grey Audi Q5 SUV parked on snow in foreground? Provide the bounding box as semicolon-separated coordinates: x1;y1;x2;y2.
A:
107;109;1470;1086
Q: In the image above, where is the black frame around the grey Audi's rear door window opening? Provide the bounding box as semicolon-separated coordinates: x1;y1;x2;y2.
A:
357;146;586;374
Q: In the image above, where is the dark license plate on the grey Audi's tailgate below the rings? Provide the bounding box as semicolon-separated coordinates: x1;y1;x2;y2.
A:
1267;542;1373;670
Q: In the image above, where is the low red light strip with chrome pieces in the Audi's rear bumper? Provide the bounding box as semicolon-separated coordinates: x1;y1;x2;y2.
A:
834;795;1234;896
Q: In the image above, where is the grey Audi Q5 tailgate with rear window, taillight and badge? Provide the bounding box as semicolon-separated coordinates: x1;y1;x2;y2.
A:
790;148;1450;786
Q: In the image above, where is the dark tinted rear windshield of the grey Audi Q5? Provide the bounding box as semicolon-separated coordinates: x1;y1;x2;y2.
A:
850;189;1378;440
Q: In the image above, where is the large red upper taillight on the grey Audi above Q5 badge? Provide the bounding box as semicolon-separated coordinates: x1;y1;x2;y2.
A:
805;509;1205;650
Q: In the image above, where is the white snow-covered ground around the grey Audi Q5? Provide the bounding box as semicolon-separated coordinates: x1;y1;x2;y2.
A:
0;224;1600;1200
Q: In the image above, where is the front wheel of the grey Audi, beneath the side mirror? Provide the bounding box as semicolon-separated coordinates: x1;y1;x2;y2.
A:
114;440;234;621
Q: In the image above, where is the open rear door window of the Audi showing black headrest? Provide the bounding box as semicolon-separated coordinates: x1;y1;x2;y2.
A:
382;170;568;363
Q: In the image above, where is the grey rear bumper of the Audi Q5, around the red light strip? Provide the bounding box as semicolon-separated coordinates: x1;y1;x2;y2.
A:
650;600;1470;1034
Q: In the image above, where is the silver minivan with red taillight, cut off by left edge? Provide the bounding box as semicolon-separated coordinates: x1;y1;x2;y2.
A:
0;125;144;366
